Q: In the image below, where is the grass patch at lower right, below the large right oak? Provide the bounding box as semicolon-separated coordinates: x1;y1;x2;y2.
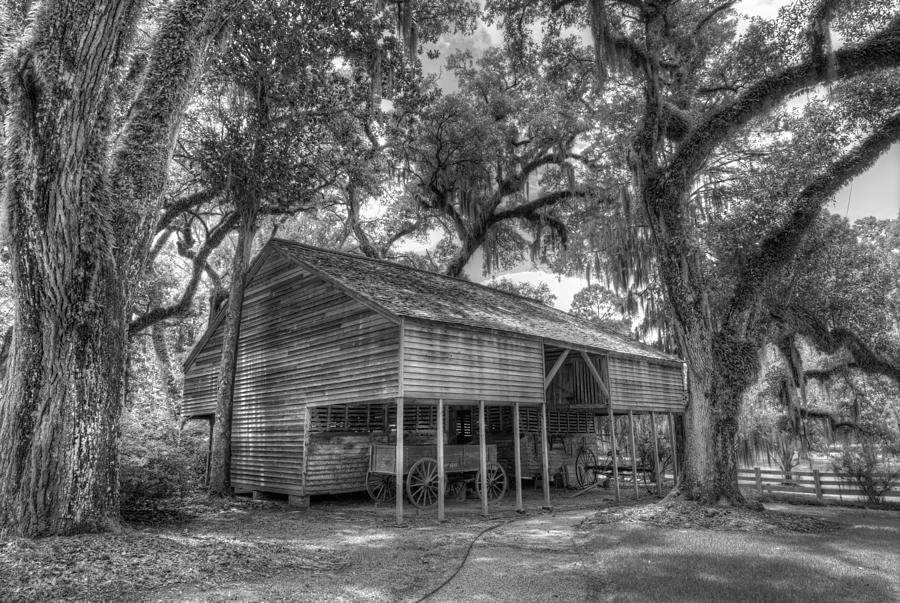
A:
580;507;900;603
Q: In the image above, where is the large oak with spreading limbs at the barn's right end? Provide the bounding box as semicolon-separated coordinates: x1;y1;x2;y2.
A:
488;0;900;502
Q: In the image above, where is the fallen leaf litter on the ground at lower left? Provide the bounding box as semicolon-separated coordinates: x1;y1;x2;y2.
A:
0;501;348;601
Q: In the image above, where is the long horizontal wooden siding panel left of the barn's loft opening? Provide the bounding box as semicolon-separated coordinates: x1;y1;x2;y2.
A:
403;320;544;403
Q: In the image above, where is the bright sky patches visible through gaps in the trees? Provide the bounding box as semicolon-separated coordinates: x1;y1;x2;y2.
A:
425;0;900;310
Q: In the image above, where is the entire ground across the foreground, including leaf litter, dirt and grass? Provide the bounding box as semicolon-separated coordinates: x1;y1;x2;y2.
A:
0;489;900;603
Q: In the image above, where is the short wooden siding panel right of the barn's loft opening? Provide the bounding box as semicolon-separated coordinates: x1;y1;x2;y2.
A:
609;356;685;412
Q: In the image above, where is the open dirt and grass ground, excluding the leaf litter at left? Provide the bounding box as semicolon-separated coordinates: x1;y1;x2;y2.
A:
142;491;900;602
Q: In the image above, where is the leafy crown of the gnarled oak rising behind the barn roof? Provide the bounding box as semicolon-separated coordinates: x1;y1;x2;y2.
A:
382;42;597;276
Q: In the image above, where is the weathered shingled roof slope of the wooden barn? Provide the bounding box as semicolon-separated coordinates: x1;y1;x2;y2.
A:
267;239;681;363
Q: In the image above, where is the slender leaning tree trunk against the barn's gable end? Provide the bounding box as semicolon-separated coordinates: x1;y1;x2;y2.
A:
209;211;256;496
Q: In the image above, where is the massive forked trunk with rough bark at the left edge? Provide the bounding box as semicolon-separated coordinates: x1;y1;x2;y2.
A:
0;0;236;536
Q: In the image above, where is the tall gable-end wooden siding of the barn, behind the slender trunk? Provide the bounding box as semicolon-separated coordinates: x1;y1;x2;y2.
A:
184;254;399;495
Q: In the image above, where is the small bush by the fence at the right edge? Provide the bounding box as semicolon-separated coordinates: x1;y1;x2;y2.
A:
832;435;900;503
